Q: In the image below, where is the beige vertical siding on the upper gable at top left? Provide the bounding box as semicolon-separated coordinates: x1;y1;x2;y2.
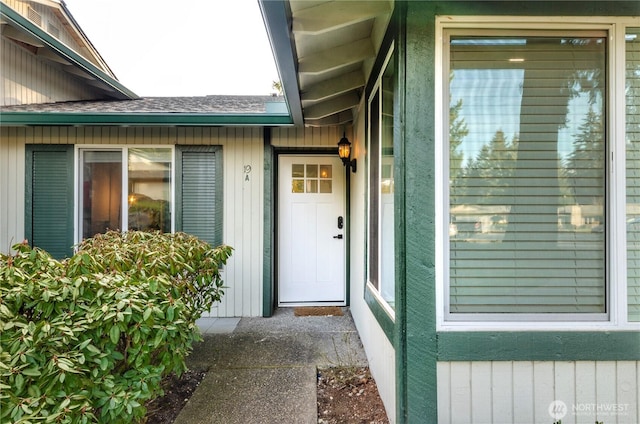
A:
0;38;98;106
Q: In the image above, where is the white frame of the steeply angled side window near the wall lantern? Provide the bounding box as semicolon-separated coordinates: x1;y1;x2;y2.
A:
365;41;397;321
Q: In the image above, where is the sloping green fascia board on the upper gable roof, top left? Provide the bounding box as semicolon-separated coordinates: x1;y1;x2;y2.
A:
0;3;138;99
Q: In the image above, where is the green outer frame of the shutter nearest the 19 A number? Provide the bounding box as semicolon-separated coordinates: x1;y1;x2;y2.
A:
174;144;224;246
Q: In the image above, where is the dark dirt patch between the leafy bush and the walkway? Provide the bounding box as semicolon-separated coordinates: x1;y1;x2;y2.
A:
145;370;207;424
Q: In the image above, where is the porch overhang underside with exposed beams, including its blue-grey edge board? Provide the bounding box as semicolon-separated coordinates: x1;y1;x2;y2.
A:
259;0;393;126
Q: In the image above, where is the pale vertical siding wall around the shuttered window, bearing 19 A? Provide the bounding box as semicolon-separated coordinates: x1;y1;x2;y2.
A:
0;127;264;317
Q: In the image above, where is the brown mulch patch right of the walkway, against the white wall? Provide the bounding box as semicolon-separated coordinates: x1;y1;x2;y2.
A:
318;367;389;424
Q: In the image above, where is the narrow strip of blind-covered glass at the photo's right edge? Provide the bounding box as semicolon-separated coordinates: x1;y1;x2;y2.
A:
625;28;640;321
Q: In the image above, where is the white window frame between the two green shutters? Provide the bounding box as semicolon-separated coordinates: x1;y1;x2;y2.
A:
73;144;176;243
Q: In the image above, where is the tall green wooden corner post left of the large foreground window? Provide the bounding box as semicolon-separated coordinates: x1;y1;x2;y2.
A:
398;2;441;423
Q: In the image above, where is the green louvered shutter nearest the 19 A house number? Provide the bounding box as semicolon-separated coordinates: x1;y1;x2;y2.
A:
176;146;222;246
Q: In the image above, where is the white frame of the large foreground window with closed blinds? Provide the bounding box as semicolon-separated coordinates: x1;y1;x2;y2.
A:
434;16;640;331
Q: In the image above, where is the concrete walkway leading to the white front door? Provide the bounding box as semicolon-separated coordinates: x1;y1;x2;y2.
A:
175;308;367;424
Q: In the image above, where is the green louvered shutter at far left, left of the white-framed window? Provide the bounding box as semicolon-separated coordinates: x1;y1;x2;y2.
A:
25;144;74;259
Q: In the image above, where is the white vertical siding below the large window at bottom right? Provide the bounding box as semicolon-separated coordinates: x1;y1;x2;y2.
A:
437;361;640;424
